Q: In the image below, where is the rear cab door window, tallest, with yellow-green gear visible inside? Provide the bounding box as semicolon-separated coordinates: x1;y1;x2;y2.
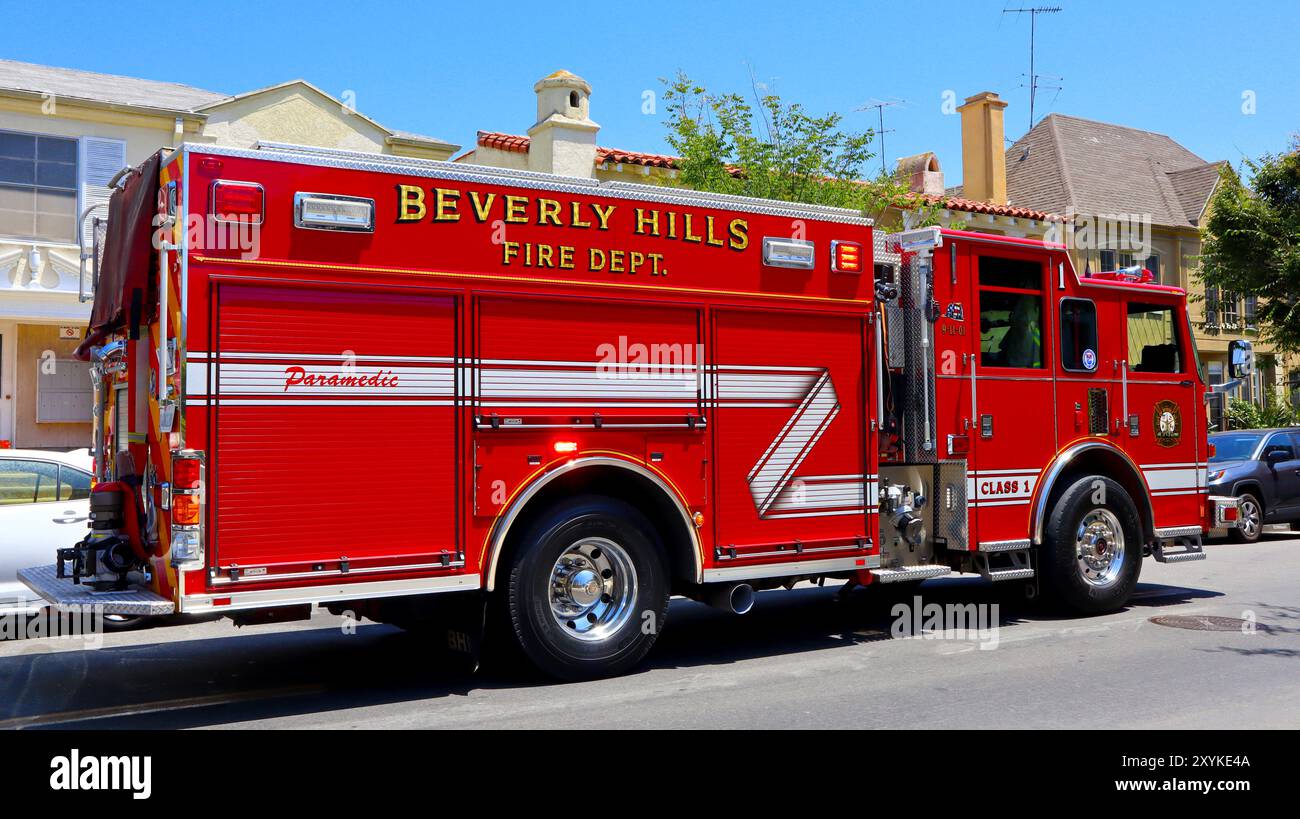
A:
979;256;1043;368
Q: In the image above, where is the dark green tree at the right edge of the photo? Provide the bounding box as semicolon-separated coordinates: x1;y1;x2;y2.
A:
1201;146;1300;351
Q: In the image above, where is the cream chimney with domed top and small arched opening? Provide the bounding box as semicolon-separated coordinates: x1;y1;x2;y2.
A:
528;70;601;177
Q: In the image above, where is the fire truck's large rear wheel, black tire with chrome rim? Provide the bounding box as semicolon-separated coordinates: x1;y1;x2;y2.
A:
506;495;670;680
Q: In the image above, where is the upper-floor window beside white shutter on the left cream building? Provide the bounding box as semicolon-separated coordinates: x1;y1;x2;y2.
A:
0;131;77;243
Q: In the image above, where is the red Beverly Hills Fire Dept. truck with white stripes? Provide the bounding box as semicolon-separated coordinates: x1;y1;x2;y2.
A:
22;146;1236;679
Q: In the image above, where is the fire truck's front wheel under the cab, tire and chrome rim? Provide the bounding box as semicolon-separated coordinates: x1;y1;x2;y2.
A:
1039;476;1143;614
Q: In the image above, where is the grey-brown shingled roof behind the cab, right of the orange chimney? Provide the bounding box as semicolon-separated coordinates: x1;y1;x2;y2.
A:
1006;113;1222;228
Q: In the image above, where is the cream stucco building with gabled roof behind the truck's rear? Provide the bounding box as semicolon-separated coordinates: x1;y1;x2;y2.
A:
0;60;459;447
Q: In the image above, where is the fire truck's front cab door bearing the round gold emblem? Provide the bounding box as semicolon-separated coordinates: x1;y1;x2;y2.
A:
1121;294;1205;528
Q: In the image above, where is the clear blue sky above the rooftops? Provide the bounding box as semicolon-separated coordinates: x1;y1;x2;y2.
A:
0;0;1300;185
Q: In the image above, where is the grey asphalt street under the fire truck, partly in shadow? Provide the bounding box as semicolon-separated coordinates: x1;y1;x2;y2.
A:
0;534;1300;728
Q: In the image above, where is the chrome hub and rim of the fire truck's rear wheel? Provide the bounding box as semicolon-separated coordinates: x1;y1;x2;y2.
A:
549;537;637;641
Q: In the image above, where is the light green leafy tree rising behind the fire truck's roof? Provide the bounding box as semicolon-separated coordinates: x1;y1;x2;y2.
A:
663;72;937;224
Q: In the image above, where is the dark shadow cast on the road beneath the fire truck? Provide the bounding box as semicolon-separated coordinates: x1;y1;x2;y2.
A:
0;579;1218;728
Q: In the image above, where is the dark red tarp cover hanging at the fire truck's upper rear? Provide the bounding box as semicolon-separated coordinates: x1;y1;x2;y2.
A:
75;153;161;360
